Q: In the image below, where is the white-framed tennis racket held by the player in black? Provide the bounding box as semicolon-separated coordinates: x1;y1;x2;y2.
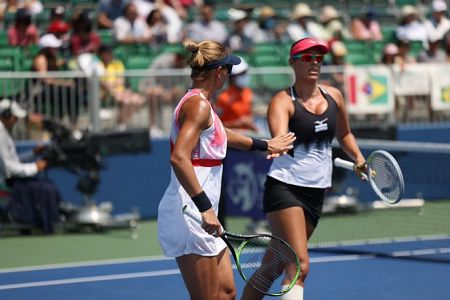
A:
334;150;405;204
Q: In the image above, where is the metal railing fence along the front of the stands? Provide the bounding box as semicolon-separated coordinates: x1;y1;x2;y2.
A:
0;66;450;140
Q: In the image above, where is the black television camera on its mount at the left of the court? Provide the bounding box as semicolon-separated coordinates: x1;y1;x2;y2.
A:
43;120;151;233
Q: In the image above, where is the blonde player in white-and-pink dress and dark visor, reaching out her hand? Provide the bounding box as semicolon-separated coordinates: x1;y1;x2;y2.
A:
158;41;295;300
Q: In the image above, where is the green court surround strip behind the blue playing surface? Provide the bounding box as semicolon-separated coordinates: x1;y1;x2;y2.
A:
0;201;450;269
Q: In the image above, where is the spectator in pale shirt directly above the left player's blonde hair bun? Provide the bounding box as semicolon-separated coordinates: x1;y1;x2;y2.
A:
186;3;228;43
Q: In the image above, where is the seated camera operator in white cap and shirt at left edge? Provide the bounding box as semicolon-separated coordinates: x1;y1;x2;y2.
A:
0;99;61;234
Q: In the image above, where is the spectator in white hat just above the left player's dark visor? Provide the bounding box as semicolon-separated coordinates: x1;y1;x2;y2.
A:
225;8;253;54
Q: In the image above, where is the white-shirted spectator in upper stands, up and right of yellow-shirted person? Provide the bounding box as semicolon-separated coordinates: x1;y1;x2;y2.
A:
114;2;151;44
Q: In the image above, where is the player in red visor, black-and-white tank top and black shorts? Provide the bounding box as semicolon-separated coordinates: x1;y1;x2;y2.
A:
243;38;366;300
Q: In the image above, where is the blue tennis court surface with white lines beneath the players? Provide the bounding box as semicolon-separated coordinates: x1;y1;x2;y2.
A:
0;253;450;300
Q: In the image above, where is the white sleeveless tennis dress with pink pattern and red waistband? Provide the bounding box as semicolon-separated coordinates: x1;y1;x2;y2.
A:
158;89;227;257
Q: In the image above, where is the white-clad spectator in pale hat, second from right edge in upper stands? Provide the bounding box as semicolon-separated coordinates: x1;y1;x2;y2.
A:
395;5;428;46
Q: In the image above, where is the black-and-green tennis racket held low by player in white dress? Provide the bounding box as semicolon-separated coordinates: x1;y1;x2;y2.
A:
182;205;300;296
